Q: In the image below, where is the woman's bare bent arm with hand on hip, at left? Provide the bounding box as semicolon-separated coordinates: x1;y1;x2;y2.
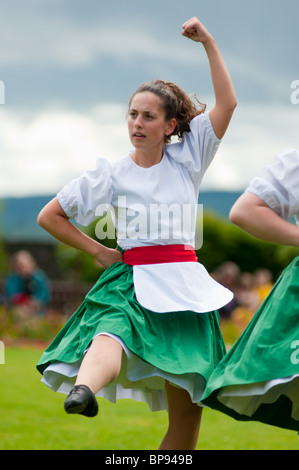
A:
37;197;122;268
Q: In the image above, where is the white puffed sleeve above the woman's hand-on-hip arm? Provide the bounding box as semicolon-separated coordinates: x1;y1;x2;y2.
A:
57;158;113;226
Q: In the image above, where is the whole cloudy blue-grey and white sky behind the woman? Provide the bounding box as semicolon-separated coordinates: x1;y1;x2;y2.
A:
0;0;299;198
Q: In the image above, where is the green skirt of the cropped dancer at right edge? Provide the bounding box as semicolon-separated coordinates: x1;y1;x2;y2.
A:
202;258;299;431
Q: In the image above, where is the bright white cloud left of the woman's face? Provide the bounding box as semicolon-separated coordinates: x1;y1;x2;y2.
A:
0;104;129;197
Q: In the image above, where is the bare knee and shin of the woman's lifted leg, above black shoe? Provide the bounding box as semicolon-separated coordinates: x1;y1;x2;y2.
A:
76;335;123;394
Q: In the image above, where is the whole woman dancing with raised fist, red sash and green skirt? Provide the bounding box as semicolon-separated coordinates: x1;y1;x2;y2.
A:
38;18;236;449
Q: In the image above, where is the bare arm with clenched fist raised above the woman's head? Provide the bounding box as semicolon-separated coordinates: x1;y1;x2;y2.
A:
182;17;237;139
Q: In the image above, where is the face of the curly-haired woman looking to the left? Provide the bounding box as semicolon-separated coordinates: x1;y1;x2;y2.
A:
128;91;176;157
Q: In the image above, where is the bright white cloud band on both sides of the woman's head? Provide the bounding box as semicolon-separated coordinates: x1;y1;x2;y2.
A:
0;103;299;197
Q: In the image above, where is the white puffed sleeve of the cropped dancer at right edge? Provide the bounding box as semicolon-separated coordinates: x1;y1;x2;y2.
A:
246;149;299;220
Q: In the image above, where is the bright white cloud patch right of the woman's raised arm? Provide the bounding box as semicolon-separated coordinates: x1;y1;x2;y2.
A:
202;103;299;191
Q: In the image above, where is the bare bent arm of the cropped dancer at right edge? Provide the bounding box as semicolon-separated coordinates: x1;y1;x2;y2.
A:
229;192;299;246
